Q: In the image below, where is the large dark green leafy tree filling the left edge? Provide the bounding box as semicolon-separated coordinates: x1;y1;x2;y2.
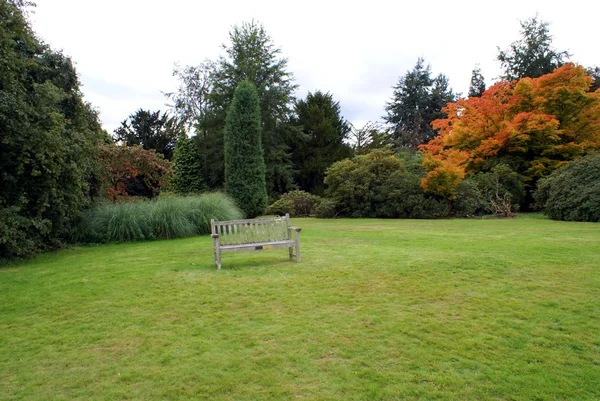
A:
0;1;105;257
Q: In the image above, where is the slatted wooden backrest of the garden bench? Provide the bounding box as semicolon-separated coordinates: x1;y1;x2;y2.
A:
210;214;291;245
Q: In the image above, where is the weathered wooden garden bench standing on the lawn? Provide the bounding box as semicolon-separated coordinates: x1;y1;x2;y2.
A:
210;214;302;269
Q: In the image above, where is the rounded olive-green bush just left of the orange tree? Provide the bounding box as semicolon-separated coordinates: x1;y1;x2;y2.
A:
325;150;446;218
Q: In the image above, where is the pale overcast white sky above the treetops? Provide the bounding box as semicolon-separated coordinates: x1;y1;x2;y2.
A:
30;0;600;132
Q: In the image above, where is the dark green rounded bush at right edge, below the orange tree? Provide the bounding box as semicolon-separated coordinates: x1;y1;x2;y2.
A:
535;153;600;222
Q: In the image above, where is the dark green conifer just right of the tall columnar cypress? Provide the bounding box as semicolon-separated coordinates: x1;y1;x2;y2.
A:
292;91;352;195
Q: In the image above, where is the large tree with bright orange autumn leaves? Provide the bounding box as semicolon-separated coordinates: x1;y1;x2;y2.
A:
420;63;600;206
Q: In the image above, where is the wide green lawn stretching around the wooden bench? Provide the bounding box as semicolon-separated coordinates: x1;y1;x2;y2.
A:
0;217;600;400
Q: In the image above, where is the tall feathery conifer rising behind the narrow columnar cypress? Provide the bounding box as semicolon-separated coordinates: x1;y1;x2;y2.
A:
210;21;297;197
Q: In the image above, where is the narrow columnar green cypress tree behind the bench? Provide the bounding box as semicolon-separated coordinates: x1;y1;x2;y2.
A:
225;80;268;218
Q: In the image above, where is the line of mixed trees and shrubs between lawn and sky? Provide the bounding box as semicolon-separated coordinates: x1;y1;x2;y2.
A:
0;0;600;257
